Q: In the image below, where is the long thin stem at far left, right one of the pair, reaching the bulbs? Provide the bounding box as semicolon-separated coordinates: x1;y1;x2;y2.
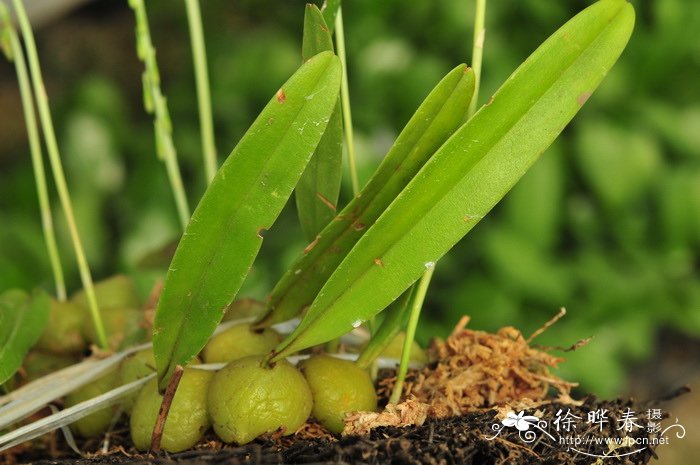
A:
13;0;109;350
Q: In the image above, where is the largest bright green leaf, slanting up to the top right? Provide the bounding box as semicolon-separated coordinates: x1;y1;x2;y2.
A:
274;0;634;359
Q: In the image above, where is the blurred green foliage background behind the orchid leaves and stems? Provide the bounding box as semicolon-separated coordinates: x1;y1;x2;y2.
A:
0;0;700;396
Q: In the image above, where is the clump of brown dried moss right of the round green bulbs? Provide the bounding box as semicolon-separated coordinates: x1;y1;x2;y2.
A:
344;313;576;434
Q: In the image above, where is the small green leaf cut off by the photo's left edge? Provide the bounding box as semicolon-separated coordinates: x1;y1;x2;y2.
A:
0;289;51;384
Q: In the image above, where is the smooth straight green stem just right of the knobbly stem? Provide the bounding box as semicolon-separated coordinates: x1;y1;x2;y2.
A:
185;0;217;182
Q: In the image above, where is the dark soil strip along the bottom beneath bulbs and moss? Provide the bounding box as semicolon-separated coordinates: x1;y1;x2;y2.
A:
12;398;671;465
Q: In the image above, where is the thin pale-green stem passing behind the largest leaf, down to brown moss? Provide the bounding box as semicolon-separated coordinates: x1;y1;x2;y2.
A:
389;0;486;398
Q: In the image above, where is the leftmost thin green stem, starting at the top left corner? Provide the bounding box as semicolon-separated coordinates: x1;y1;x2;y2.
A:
0;3;66;302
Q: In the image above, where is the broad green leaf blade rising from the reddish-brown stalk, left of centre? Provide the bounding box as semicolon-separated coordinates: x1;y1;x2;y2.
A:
153;52;340;388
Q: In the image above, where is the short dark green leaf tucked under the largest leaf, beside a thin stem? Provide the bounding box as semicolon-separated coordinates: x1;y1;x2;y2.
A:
355;285;416;368
